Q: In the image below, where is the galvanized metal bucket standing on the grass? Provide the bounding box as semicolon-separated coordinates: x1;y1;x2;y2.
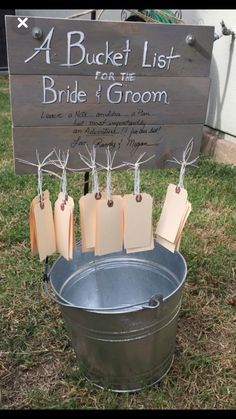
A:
44;244;187;392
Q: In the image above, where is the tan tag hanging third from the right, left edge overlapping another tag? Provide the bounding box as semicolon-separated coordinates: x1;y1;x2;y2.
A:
95;195;123;256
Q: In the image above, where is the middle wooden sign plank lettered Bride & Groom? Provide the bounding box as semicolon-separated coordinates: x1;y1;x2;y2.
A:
10;75;210;126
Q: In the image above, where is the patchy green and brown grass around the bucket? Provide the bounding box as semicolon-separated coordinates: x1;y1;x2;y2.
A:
0;77;236;410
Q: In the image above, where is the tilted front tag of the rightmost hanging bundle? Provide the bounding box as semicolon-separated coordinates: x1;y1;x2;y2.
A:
156;184;188;243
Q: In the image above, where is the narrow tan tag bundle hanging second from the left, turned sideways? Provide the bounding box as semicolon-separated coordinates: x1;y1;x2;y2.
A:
54;192;75;260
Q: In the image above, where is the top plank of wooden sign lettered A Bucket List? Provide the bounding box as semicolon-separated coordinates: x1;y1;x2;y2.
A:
6;16;214;77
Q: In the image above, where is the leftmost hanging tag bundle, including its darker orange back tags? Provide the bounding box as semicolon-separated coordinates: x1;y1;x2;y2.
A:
30;191;56;262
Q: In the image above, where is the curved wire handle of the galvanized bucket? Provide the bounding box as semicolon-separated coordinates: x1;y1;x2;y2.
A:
43;258;163;312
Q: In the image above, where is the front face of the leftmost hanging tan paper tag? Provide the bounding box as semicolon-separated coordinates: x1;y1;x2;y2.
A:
34;195;56;262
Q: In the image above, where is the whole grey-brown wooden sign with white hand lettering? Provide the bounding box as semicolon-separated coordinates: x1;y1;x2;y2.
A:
6;16;214;174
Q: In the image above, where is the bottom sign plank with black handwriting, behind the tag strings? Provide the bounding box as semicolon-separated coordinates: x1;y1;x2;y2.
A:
13;124;202;174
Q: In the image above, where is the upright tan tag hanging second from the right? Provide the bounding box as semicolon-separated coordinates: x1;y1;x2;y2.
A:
123;193;153;252
